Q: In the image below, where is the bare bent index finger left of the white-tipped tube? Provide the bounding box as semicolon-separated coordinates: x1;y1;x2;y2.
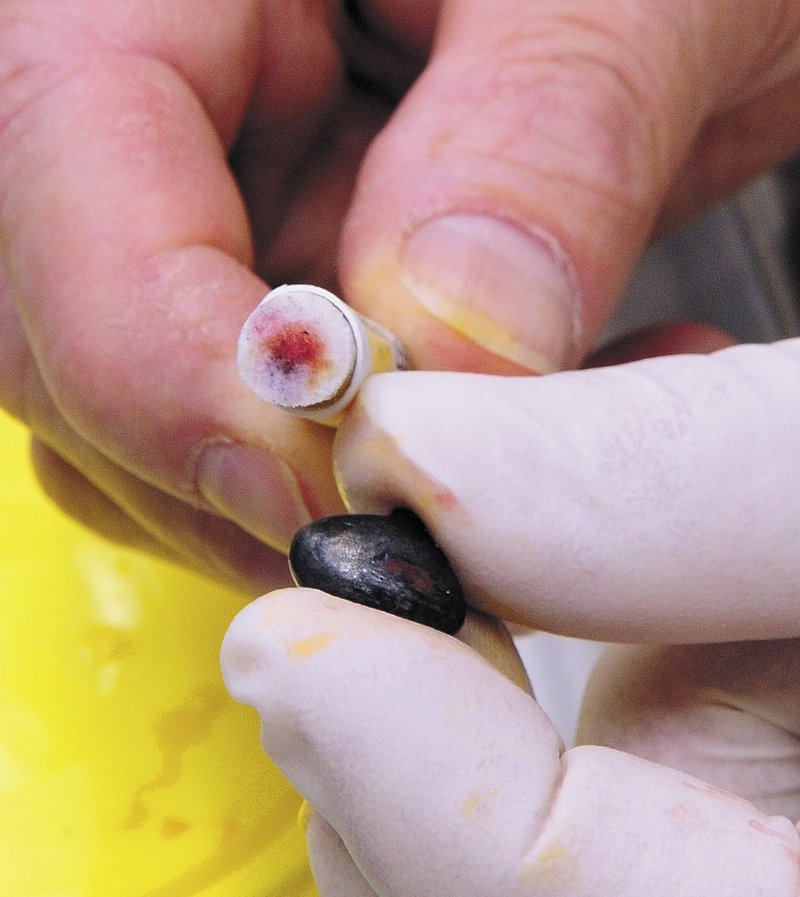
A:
0;3;346;544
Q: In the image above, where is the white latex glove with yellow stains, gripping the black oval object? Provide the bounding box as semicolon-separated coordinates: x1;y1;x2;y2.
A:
223;341;800;897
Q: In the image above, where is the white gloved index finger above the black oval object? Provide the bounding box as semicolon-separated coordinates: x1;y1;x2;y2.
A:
336;340;800;643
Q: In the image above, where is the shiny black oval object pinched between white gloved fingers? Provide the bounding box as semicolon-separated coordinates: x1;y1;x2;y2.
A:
289;508;466;634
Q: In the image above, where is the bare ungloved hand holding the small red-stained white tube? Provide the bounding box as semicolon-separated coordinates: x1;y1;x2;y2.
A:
0;0;800;590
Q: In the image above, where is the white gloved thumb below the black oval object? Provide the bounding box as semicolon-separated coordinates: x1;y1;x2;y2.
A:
222;589;798;897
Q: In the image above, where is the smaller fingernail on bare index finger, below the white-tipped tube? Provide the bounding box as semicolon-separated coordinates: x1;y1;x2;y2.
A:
197;442;312;552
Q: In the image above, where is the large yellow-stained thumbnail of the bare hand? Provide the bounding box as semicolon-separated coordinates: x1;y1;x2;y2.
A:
401;214;579;373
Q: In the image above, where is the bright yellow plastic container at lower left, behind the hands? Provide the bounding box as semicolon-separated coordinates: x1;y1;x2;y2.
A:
0;413;315;897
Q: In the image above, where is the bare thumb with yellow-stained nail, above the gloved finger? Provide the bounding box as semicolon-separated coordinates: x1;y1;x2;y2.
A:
340;0;800;373
